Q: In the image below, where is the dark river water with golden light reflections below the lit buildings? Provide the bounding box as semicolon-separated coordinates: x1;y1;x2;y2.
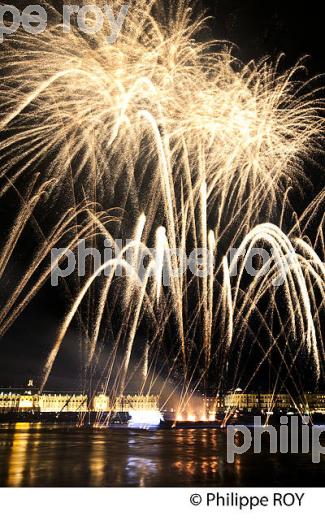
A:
0;423;325;487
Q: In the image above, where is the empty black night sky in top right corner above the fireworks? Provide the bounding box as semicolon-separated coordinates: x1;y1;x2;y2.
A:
204;0;325;74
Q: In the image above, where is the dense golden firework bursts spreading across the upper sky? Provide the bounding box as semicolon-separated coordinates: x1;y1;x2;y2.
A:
0;2;322;218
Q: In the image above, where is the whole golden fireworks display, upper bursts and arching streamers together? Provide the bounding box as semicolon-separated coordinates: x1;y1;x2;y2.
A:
0;0;325;414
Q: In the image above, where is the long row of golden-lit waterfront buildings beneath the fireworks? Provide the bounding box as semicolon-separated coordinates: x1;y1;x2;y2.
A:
0;380;325;421
